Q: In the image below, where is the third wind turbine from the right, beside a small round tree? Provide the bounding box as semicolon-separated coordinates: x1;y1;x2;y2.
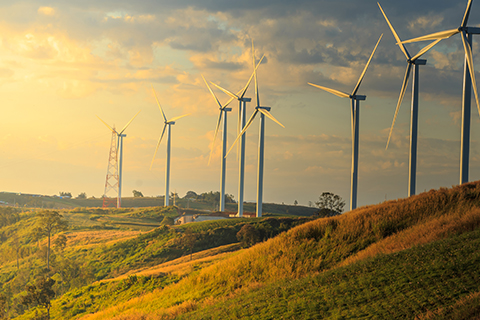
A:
308;33;383;210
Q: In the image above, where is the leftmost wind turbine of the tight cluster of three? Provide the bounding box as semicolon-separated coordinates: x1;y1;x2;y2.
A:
202;75;233;212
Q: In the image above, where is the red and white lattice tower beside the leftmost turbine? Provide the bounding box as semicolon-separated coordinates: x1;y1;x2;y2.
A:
103;128;121;208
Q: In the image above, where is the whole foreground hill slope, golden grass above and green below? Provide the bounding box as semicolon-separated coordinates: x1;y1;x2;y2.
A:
70;182;480;319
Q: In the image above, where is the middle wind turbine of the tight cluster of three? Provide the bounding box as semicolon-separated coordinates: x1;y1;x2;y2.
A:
210;55;265;217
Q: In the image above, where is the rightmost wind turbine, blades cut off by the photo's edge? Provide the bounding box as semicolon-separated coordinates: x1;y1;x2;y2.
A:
402;0;480;184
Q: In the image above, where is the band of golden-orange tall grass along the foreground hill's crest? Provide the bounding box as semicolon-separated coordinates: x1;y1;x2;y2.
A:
72;182;480;319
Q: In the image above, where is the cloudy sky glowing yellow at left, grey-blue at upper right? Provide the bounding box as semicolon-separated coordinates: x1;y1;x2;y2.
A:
0;0;480;208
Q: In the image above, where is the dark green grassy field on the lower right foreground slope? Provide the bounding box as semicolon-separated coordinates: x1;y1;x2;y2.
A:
178;230;480;319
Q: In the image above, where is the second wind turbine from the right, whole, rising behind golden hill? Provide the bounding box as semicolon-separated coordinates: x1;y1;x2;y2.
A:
377;2;442;196
